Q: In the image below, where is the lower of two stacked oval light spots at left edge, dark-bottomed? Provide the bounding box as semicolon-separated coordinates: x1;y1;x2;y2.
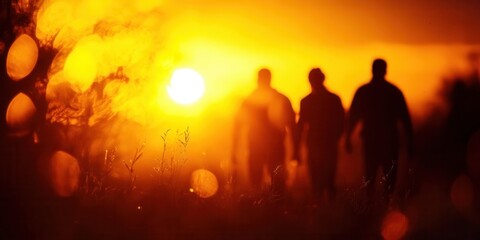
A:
6;93;37;137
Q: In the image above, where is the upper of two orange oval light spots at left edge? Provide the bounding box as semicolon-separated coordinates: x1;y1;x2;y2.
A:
7;34;38;81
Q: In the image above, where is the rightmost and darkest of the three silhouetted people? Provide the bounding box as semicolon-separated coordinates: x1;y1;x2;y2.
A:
345;59;413;202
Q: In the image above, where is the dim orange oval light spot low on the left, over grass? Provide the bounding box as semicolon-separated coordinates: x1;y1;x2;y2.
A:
50;151;80;197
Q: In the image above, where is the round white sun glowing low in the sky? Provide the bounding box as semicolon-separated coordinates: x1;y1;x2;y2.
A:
167;68;205;105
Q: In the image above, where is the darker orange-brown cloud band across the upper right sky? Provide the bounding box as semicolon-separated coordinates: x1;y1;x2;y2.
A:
165;0;480;45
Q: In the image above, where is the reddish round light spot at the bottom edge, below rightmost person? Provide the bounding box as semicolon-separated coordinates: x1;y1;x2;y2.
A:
382;210;409;240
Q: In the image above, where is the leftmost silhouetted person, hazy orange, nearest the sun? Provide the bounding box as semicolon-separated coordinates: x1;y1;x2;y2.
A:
232;68;295;194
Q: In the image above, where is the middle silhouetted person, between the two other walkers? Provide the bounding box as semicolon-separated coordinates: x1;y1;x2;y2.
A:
295;68;345;200
